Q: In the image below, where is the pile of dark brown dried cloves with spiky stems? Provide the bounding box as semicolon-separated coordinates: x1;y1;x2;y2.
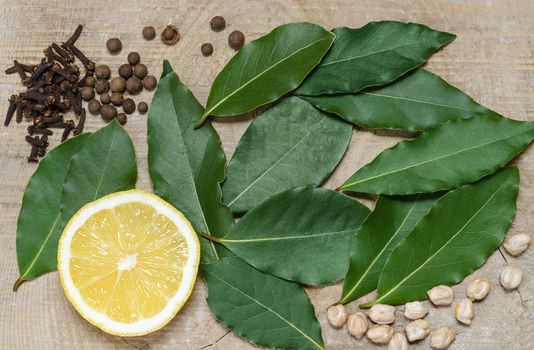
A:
4;25;95;162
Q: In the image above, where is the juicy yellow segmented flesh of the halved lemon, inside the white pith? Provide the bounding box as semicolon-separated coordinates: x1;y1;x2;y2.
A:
69;202;189;323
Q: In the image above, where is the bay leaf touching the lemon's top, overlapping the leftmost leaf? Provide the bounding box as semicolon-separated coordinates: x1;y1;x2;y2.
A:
61;119;137;226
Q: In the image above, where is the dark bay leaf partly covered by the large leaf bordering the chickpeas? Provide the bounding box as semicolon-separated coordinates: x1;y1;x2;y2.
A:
340;195;438;304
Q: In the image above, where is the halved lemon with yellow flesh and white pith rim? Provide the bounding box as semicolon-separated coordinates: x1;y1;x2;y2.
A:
58;190;200;336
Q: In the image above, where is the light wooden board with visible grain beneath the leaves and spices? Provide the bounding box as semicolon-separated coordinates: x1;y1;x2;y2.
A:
0;0;534;350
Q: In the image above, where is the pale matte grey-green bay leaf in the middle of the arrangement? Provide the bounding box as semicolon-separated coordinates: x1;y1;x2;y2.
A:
222;97;352;213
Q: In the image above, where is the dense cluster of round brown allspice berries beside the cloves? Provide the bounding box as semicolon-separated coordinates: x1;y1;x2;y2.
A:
81;50;157;125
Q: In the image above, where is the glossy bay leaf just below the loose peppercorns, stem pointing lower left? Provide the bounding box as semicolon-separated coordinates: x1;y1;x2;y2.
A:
197;23;334;127
